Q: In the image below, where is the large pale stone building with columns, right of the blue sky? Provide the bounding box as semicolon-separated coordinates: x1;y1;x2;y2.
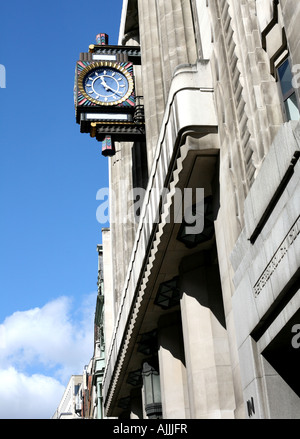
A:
102;0;300;419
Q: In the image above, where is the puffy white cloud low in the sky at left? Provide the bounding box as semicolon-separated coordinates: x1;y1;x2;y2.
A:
0;293;96;419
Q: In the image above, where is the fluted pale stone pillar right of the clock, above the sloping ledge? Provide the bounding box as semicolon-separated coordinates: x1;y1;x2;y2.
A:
139;0;197;171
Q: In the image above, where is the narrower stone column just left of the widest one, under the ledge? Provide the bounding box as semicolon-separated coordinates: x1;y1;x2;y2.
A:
158;313;189;419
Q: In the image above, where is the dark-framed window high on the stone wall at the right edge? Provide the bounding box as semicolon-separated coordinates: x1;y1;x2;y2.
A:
277;59;300;120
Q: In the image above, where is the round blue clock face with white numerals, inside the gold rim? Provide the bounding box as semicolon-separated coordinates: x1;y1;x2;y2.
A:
83;67;129;105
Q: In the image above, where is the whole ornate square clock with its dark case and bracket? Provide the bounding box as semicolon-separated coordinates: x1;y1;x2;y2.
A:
74;34;145;156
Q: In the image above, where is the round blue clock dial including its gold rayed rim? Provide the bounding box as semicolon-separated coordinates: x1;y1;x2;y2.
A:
78;61;134;106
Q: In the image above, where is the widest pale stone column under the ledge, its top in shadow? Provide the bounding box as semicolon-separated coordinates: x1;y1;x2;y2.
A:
180;256;235;419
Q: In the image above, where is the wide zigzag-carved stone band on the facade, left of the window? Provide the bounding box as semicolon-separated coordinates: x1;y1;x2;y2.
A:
214;0;282;191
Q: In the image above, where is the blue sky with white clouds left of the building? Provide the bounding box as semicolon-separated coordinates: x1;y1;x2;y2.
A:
0;0;122;419
